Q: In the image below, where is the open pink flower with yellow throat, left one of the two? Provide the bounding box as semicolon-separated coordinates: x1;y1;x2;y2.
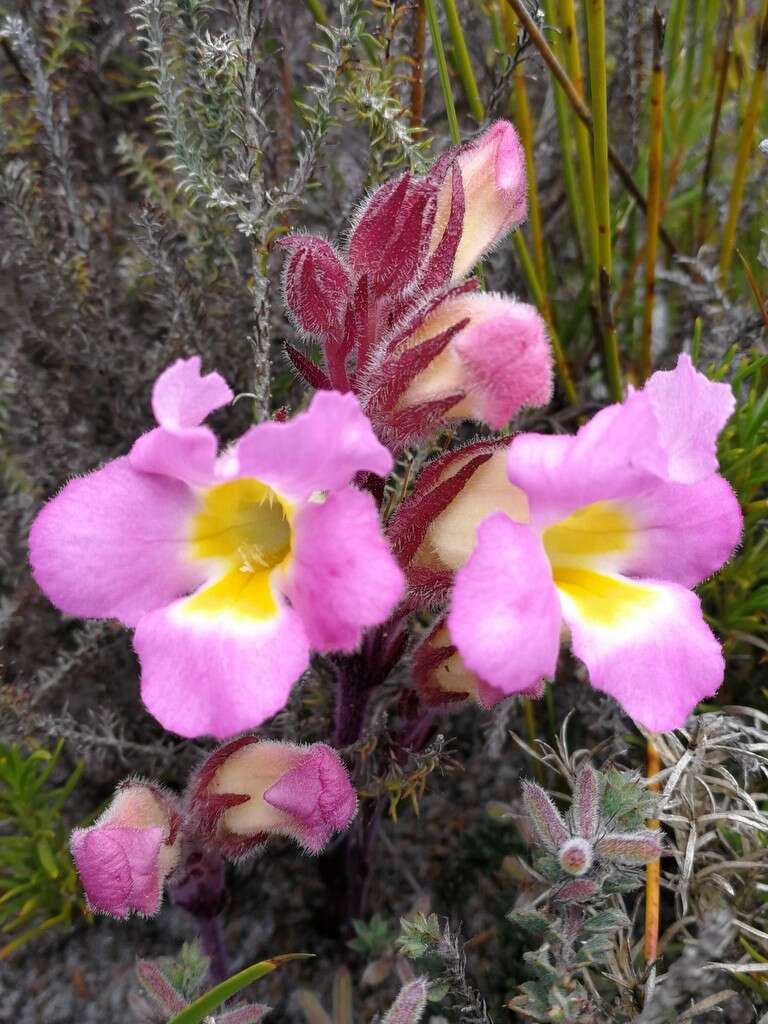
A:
30;356;402;738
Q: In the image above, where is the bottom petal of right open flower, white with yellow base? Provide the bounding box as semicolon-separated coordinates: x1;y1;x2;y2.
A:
555;569;724;732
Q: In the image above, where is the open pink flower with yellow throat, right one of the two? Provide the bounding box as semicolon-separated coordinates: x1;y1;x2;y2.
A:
444;355;741;730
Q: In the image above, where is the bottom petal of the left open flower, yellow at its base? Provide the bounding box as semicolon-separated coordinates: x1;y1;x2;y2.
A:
133;581;309;739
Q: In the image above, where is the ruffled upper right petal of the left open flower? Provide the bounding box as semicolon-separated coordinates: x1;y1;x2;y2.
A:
237;391;392;500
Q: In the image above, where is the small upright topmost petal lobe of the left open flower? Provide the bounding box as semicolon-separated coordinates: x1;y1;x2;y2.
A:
152;355;232;430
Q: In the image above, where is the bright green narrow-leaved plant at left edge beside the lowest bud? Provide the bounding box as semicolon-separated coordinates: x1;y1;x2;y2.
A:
0;740;83;958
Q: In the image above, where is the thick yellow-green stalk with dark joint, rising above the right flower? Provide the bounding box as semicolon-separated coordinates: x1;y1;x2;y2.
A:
586;0;622;401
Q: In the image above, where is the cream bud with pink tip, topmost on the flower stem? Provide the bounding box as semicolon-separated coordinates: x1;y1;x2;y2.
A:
430;121;527;281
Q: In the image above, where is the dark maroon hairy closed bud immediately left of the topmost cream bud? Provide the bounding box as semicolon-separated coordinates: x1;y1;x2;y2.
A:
349;174;437;295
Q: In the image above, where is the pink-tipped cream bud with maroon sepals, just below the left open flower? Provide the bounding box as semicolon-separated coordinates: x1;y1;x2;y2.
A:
189;736;357;859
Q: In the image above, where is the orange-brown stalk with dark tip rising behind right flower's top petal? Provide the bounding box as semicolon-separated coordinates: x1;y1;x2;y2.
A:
640;7;665;382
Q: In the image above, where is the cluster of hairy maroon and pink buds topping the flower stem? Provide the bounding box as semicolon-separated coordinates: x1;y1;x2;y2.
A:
281;121;552;452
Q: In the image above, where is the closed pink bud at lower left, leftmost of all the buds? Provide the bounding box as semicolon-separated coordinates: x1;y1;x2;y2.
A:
70;781;181;918
